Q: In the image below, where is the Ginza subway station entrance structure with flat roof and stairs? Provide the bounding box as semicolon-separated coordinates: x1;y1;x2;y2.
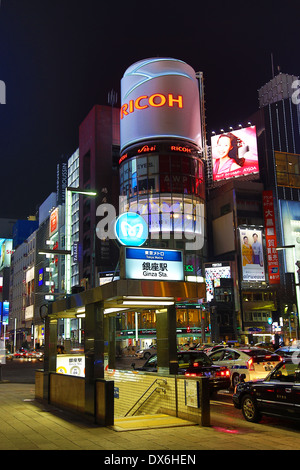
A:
36;280;210;425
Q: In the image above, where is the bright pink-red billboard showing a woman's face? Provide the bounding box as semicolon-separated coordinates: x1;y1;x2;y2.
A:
211;126;259;181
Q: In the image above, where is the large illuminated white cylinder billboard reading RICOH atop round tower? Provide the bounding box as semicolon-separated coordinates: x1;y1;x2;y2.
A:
120;58;201;152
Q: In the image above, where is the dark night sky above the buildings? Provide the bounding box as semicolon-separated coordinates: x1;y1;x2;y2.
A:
0;0;300;219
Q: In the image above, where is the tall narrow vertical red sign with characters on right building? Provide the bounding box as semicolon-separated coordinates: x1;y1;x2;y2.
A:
263;191;280;284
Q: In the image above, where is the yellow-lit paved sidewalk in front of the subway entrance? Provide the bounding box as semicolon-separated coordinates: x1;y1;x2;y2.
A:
0;382;300;456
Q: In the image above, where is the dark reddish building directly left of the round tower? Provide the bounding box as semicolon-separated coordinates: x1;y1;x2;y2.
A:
79;105;120;288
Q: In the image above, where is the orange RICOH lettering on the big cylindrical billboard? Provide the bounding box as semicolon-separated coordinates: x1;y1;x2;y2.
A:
121;93;183;119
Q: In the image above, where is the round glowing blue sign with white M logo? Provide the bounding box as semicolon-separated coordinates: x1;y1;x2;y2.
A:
115;212;148;246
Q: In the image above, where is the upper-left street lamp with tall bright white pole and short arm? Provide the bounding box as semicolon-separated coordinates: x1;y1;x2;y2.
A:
65;187;97;294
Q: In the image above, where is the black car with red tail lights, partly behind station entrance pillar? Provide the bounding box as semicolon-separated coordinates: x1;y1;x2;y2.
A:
132;350;230;391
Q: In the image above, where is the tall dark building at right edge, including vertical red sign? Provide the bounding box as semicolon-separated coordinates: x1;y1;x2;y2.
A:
250;73;300;342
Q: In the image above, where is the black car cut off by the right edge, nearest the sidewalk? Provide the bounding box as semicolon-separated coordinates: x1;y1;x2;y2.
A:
232;358;300;423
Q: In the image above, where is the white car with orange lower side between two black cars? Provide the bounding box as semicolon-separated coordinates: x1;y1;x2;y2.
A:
209;348;282;388
